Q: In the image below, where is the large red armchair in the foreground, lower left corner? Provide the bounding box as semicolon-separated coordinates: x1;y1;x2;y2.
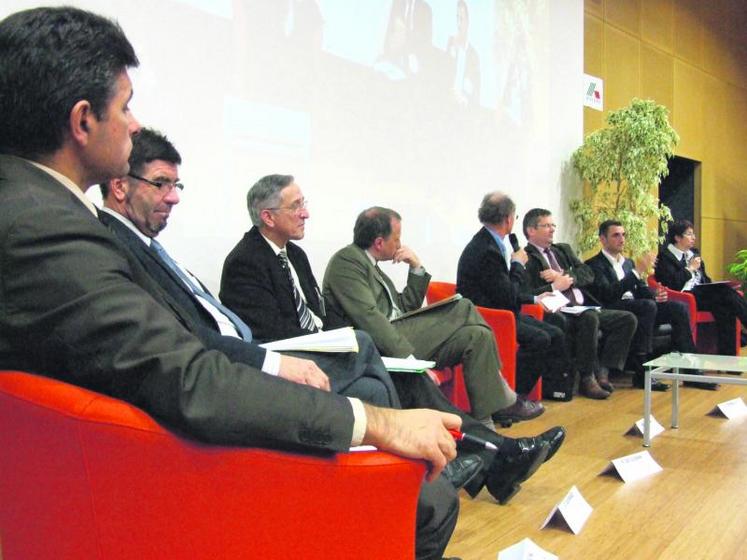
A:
0;371;424;560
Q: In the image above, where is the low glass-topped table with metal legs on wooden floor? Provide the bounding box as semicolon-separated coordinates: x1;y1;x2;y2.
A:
643;352;747;447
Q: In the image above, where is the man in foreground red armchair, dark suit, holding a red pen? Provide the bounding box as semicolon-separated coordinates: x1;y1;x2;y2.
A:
0;7;468;558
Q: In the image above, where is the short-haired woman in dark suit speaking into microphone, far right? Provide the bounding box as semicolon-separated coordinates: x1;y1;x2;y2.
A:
655;220;747;356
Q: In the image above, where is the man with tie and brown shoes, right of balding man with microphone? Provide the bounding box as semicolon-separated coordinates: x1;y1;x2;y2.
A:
523;208;637;399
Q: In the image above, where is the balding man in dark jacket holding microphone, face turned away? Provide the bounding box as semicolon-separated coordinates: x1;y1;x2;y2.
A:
457;192;568;395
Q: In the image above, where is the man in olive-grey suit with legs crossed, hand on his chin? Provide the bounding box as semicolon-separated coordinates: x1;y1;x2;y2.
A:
323;207;544;423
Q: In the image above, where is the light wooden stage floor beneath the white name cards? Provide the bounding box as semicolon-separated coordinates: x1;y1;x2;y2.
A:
446;368;747;560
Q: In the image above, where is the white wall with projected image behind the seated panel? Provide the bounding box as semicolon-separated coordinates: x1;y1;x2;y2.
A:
0;0;583;290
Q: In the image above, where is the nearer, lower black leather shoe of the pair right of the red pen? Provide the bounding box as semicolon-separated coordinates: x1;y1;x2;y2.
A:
474;438;550;505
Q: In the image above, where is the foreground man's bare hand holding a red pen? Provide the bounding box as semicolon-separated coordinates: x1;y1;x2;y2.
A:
363;404;462;481
